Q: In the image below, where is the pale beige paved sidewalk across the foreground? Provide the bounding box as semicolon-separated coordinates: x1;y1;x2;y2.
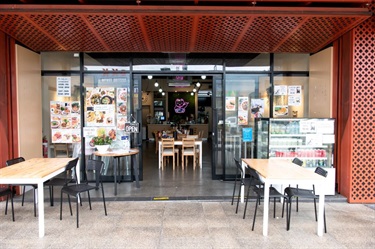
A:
0;201;375;249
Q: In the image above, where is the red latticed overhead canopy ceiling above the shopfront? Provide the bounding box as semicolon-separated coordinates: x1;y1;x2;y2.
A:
0;0;371;53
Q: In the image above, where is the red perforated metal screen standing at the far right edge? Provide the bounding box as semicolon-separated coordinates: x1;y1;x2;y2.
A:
349;3;375;203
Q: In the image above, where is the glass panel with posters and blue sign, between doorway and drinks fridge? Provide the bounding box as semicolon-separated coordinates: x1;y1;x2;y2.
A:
223;74;271;179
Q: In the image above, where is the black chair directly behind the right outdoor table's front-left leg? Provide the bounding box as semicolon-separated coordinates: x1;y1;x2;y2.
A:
243;168;289;231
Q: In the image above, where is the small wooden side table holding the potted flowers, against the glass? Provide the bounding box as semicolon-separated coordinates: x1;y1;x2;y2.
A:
94;148;140;195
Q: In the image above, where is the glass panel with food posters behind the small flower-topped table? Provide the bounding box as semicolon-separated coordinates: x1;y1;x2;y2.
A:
82;73;133;181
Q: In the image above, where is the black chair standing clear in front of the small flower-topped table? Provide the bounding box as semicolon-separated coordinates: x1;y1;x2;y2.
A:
60;159;107;228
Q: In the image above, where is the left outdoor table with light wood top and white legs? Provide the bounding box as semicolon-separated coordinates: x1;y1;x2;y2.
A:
0;158;73;237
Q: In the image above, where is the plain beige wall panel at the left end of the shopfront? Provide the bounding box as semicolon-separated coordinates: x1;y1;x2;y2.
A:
16;46;43;159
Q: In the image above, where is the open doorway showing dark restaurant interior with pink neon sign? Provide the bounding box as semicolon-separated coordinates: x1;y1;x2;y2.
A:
132;72;223;179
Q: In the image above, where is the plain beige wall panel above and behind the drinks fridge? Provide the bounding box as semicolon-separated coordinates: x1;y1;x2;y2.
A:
308;47;333;118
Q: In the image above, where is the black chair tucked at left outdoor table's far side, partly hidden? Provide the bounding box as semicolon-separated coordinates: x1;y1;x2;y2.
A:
44;157;78;206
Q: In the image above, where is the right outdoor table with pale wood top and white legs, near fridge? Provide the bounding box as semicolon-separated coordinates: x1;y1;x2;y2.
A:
241;159;326;236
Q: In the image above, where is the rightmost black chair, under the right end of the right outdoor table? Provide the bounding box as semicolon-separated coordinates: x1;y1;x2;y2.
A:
283;167;328;233
